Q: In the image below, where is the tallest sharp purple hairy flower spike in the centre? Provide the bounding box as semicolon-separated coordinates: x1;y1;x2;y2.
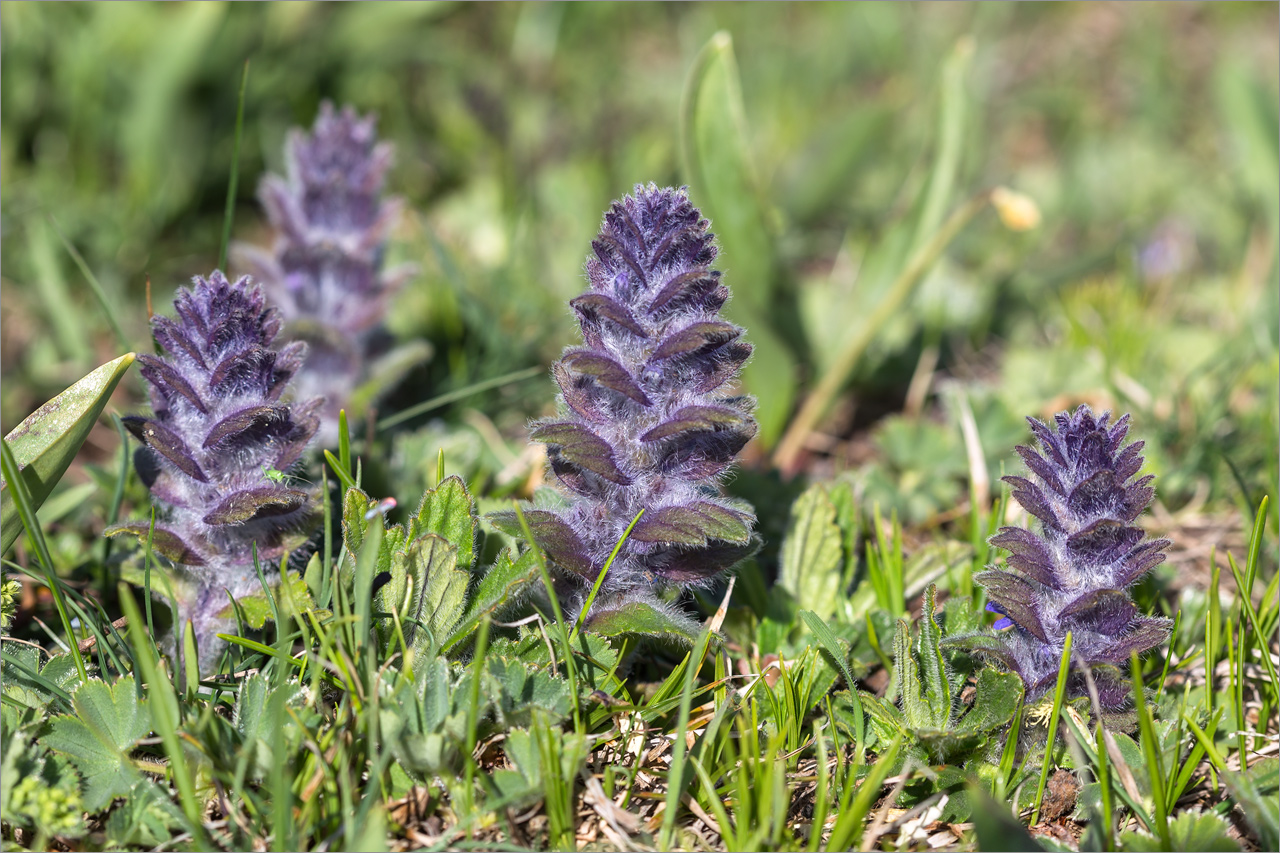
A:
492;184;756;633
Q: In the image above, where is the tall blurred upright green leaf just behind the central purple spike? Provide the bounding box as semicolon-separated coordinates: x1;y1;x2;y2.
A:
680;31;795;446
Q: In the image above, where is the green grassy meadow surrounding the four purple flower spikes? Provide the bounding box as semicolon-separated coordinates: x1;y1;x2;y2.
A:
0;3;1280;852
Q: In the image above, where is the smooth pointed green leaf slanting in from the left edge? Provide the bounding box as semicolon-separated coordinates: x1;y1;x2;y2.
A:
0;352;134;553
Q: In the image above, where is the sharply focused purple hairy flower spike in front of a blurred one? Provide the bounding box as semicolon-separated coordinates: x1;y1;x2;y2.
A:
106;272;321;656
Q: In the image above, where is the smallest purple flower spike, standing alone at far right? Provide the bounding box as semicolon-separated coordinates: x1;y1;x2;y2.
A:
957;406;1171;721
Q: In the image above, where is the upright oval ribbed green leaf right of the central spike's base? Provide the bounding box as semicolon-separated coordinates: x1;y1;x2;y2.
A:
778;484;844;620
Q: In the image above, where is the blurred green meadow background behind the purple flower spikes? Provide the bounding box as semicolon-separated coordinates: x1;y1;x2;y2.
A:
0;1;1280;532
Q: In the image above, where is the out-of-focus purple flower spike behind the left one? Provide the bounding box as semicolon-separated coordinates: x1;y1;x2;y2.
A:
234;101;412;444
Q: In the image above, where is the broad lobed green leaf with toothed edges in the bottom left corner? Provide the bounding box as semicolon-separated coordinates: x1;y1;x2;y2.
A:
41;675;151;812
